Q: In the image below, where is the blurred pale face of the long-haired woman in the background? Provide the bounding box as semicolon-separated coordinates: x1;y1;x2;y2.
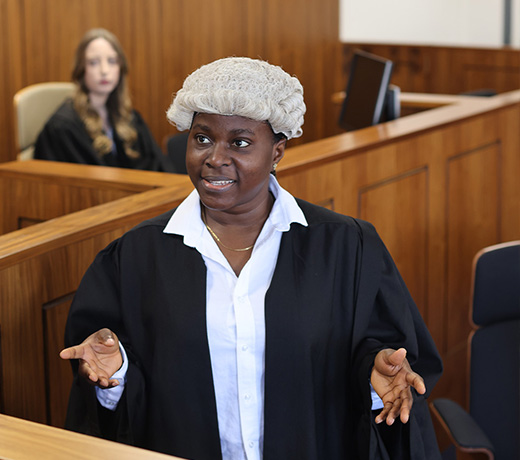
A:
84;38;120;97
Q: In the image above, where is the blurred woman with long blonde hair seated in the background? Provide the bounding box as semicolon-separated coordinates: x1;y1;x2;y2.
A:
34;29;171;171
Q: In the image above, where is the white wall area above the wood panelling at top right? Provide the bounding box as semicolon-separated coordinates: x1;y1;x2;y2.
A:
339;0;520;47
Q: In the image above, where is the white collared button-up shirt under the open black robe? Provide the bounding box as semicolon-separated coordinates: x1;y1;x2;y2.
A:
164;176;307;460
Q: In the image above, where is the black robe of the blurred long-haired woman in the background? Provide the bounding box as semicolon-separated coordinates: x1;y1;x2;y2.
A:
34;99;172;171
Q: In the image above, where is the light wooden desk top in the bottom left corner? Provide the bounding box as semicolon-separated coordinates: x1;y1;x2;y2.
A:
0;414;184;460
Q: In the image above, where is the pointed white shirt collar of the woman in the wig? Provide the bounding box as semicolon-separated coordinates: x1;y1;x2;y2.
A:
163;174;307;247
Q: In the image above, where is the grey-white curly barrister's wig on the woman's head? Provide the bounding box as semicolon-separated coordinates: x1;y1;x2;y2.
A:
167;57;306;139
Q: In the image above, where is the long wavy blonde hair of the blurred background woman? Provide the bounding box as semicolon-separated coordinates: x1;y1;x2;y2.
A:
72;29;140;159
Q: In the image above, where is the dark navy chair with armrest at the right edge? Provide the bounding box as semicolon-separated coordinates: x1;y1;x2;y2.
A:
430;241;520;460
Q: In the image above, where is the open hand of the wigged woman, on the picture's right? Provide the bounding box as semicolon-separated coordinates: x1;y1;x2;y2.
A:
370;348;426;425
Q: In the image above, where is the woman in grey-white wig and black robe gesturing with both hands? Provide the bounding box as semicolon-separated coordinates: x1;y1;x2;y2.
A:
61;58;442;460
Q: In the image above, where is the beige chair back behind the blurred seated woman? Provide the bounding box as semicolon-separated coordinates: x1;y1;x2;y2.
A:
14;82;75;160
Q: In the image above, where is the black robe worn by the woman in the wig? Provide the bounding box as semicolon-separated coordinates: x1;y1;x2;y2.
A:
66;200;442;460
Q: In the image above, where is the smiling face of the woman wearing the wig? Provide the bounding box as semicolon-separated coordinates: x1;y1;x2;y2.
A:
186;113;285;214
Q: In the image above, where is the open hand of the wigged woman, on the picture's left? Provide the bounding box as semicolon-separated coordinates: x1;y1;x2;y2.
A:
60;328;123;388
